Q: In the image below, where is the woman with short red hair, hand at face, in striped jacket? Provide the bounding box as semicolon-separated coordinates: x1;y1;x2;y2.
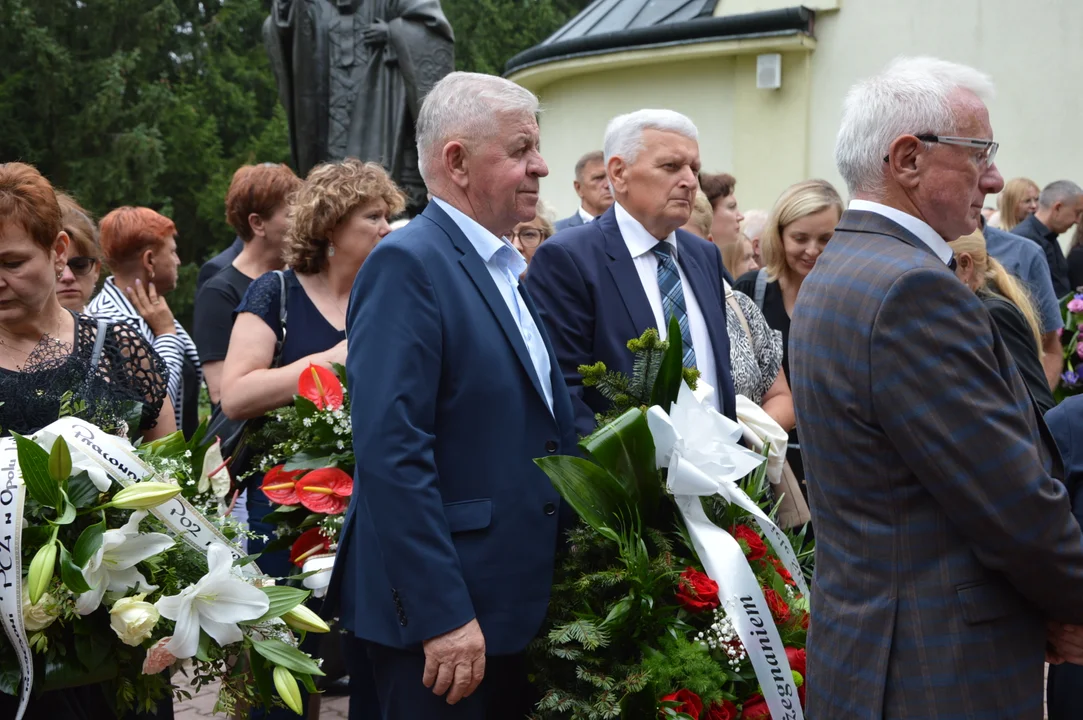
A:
87;207;203;437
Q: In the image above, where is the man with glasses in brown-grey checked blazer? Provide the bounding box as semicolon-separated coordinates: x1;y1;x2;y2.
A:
790;57;1083;720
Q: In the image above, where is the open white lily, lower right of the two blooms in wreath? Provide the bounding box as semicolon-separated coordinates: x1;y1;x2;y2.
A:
155;542;271;659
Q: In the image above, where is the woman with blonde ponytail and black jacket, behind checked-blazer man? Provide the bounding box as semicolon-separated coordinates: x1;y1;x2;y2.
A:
949;230;1056;416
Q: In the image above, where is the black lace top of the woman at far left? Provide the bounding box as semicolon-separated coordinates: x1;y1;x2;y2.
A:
0;314;167;435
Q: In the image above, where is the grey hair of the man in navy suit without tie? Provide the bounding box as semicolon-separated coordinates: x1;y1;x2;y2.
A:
417;73;539;184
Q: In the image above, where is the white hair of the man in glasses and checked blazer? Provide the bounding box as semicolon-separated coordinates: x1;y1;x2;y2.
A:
835;57;993;195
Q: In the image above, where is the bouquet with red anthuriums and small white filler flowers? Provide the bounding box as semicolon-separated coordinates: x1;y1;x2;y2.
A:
252;365;354;597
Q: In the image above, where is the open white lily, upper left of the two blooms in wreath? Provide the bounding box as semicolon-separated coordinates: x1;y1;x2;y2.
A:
75;510;174;615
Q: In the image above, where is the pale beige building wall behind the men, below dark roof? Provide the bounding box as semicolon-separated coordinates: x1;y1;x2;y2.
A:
512;0;1083;227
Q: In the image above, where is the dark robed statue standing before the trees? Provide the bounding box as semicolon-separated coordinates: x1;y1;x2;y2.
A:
263;0;455;214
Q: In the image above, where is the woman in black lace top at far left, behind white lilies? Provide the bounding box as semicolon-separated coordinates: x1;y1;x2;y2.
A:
0;162;177;720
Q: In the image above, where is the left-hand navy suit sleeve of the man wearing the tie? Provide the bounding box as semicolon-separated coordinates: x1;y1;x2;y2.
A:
525;243;595;435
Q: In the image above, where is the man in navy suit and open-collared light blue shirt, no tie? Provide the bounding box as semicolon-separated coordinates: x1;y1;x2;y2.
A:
328;73;576;720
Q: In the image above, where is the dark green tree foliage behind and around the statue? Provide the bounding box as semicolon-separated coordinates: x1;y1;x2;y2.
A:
0;0;588;322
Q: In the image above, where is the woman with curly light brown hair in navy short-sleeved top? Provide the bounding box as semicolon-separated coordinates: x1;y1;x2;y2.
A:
221;159;405;718
